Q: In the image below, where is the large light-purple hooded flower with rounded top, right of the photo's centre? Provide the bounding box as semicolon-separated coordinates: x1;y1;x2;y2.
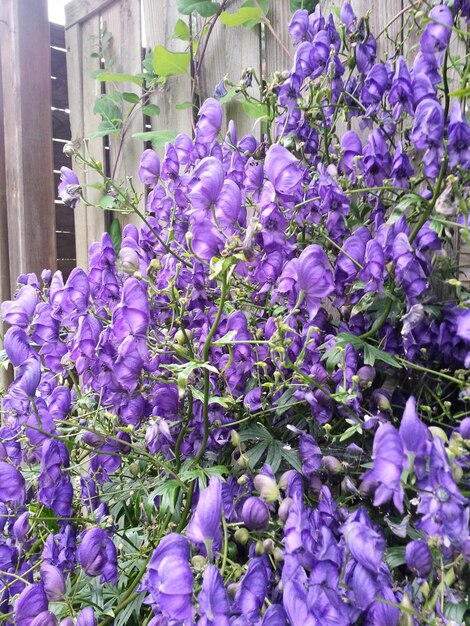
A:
297;244;334;319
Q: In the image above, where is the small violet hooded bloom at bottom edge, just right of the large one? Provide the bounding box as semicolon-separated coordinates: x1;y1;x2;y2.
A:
198;565;229;626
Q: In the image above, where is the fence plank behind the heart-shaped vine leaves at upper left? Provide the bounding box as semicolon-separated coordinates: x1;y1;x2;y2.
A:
101;0;144;226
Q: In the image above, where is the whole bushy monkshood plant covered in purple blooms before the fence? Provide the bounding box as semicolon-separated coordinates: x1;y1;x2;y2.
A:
0;0;470;626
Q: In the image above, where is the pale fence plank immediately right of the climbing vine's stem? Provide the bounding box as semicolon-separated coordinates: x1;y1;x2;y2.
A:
195;0;261;137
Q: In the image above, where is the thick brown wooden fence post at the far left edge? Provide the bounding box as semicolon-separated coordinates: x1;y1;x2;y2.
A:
0;0;56;288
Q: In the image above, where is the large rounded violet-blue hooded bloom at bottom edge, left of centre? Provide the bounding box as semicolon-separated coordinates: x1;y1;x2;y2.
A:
143;533;193;625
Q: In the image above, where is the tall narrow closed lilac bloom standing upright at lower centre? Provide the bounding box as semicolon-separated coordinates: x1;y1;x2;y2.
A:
186;476;222;558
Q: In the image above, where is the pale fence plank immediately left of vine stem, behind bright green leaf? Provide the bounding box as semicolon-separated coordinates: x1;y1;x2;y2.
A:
142;0;192;139
